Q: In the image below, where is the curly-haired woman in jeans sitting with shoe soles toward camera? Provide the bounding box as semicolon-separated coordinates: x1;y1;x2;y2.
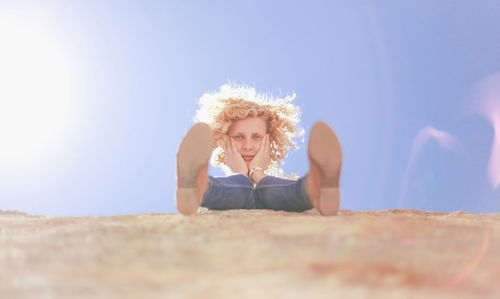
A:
177;85;342;215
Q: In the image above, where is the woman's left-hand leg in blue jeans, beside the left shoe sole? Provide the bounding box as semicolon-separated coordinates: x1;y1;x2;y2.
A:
201;174;256;210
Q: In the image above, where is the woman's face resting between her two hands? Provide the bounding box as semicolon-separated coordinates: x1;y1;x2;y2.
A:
228;117;267;167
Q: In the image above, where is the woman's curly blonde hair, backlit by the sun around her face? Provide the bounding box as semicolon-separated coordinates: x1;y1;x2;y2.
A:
194;83;304;174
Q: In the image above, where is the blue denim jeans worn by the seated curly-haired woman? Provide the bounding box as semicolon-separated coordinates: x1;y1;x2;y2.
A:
201;174;313;212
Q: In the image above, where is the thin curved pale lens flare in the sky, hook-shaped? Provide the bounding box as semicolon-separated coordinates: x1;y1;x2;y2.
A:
398;126;463;207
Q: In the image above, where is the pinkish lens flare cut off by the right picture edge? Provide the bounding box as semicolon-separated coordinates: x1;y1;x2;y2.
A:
473;74;500;189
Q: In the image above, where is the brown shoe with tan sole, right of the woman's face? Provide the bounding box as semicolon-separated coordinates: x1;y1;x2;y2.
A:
306;122;342;216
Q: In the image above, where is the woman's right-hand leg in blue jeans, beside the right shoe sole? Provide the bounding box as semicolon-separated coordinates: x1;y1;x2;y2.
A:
254;176;313;212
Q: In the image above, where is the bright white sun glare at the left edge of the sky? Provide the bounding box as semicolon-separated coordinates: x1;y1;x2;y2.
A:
0;16;70;165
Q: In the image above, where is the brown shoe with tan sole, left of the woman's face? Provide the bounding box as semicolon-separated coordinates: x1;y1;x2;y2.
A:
177;123;214;215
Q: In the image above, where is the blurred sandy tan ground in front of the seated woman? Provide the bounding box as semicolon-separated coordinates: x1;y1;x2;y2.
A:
0;209;500;298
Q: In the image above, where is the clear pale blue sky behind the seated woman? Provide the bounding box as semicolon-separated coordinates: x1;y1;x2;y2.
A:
0;1;500;216
